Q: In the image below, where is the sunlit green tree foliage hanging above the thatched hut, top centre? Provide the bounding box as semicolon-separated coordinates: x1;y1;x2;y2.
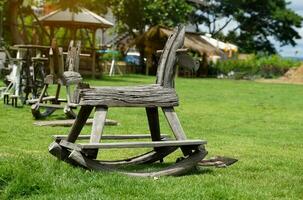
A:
109;0;192;34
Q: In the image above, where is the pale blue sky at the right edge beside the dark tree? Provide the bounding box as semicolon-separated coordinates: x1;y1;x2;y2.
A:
276;0;303;57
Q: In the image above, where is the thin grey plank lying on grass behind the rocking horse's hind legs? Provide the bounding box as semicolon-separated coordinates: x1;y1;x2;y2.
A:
33;119;118;126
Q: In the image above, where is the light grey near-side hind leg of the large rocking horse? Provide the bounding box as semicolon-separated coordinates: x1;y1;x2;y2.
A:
90;107;107;143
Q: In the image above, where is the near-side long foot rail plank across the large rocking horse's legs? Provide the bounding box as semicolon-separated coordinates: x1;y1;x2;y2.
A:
60;140;207;150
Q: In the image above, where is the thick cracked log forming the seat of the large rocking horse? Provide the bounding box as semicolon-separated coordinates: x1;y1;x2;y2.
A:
79;84;179;107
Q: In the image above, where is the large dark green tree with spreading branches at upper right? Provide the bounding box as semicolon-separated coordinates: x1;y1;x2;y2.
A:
191;0;303;53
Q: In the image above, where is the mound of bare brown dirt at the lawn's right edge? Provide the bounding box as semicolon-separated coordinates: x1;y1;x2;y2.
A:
256;64;303;84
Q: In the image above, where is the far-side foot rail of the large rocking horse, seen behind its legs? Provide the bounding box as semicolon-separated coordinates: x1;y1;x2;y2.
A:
53;134;168;140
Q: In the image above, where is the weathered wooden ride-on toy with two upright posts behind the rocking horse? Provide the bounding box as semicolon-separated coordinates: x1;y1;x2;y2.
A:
28;40;89;119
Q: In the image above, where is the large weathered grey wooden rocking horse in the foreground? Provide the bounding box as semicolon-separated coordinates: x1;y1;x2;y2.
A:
49;27;207;177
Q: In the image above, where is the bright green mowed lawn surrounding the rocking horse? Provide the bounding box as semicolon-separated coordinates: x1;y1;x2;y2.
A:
0;75;303;199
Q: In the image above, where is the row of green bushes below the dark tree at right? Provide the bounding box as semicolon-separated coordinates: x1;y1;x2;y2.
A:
214;55;300;78
